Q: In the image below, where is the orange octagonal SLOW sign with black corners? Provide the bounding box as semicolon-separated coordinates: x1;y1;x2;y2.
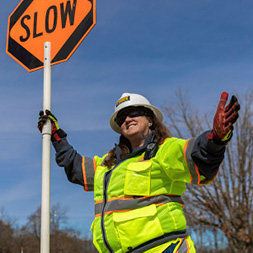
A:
6;0;96;71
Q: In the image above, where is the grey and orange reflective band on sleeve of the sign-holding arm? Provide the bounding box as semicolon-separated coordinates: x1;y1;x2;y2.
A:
83;157;95;191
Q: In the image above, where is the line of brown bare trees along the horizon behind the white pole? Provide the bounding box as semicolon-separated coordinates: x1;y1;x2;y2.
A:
0;205;97;253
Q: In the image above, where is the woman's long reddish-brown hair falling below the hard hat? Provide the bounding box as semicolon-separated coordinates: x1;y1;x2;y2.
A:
104;116;169;167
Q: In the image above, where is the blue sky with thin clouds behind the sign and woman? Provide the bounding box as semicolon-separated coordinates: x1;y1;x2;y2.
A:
0;0;253;234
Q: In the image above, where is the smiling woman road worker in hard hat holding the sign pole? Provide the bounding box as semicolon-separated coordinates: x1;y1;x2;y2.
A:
38;92;239;253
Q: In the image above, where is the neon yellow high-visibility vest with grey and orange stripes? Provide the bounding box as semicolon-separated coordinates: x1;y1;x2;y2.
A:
82;138;212;253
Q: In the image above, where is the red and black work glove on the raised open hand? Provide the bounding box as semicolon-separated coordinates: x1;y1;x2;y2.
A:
207;92;240;144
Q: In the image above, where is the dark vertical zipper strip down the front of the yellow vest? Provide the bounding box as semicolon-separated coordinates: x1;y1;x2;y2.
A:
101;170;113;253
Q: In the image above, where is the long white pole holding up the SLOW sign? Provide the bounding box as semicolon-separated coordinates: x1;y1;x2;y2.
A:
40;42;51;253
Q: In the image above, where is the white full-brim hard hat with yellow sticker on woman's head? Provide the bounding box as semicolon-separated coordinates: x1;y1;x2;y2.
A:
110;93;163;134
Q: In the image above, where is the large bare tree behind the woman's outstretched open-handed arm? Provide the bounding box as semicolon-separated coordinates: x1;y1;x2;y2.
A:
163;89;253;253
